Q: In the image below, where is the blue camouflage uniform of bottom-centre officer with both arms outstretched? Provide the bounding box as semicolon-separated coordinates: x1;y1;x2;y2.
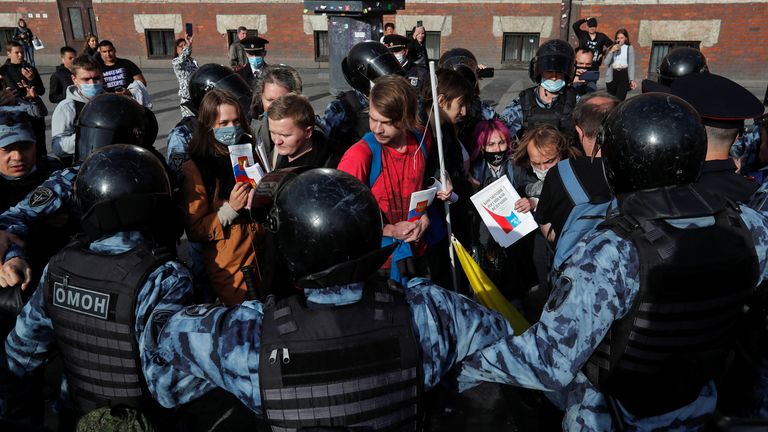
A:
141;279;513;413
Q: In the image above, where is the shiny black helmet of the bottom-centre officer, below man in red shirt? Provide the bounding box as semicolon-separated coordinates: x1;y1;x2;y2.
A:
251;168;384;286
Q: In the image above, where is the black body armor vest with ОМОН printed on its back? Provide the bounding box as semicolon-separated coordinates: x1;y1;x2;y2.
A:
44;241;171;416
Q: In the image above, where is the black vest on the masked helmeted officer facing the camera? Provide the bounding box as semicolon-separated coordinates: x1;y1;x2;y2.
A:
518;86;578;144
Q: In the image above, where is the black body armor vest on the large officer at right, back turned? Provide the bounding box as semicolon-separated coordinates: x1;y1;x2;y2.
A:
584;186;759;417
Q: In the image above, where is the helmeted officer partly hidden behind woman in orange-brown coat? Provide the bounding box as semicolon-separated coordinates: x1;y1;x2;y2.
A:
166;63;252;178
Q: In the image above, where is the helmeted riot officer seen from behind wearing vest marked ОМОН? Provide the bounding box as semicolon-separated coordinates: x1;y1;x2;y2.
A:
0;145;192;430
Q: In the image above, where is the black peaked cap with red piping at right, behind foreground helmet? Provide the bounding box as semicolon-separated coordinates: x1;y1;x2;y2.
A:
671;72;763;129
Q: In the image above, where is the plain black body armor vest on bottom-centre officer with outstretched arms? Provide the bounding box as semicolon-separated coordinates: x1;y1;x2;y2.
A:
259;282;423;431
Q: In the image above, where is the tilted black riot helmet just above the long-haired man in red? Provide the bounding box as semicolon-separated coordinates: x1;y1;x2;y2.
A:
341;41;405;95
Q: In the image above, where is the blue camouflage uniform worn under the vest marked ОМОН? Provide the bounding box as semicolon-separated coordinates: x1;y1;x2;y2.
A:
0;231;193;417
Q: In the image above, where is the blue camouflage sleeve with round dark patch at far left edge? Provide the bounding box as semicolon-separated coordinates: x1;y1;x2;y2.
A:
0;166;80;261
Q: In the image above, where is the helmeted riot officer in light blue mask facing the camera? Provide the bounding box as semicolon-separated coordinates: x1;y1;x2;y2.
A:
501;39;576;142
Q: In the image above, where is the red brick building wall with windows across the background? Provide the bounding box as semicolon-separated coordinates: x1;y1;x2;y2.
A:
0;0;768;79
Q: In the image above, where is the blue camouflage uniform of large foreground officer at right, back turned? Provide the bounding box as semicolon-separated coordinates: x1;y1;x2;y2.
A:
452;206;768;431
